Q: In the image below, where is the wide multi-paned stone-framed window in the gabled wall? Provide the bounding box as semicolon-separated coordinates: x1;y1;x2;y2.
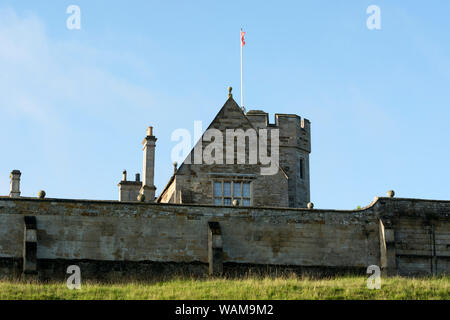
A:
212;179;253;207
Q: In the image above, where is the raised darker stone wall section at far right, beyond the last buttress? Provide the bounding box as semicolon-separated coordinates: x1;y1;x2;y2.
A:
376;199;450;275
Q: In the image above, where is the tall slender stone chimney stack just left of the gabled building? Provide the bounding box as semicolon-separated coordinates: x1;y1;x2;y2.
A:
140;127;157;202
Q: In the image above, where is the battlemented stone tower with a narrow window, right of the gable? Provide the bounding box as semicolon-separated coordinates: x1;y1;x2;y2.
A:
246;110;311;208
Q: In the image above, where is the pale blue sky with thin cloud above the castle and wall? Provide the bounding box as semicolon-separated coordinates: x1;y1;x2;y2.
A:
0;0;450;209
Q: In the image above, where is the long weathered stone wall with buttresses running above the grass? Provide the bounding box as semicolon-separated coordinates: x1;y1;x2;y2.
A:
0;197;450;278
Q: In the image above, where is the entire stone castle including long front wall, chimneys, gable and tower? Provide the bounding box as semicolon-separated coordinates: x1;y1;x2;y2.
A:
0;91;450;280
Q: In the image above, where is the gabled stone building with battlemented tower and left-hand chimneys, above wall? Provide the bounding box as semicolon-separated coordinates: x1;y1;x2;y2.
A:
119;92;311;208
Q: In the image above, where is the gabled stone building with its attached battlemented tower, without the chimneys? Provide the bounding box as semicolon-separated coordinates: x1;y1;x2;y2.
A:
156;93;311;208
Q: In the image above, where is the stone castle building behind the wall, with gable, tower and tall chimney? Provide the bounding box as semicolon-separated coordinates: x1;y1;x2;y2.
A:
119;90;311;208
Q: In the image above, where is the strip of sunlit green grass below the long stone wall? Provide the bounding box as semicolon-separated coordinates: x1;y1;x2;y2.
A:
0;276;450;300
